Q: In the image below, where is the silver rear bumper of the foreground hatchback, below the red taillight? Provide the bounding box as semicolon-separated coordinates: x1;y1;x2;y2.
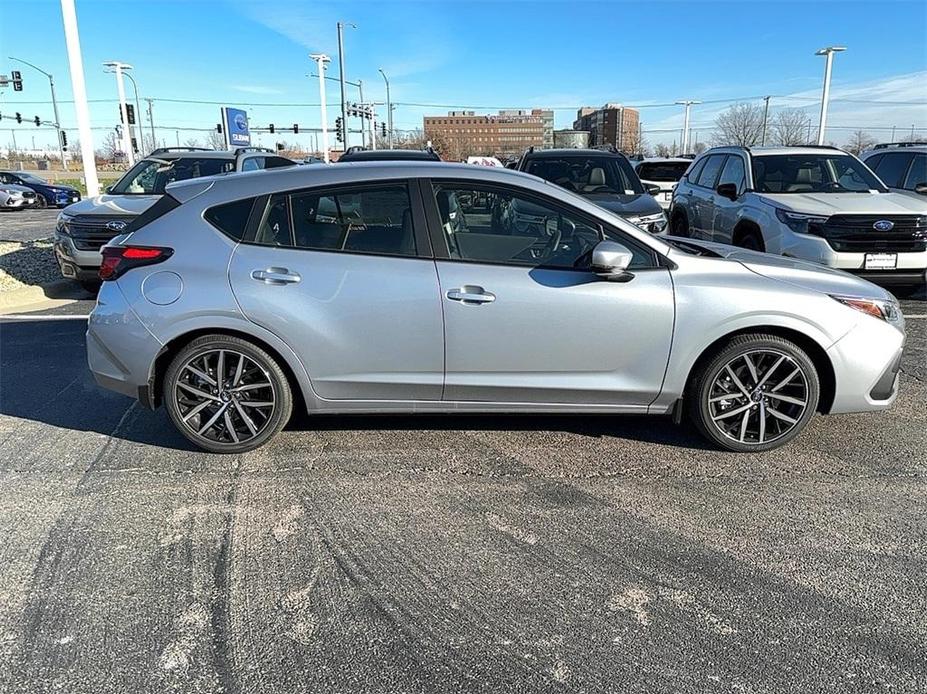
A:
87;282;162;406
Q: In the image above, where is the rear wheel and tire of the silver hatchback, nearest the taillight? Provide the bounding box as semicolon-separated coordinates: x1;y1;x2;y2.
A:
163;335;293;453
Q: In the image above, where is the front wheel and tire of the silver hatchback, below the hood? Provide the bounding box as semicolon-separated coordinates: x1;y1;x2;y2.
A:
686;334;821;453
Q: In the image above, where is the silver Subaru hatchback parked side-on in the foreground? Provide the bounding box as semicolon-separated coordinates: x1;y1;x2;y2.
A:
87;162;905;453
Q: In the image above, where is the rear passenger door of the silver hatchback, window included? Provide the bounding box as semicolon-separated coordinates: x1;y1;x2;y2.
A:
229;181;444;400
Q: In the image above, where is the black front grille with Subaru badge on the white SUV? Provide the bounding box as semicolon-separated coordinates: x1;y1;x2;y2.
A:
811;214;927;253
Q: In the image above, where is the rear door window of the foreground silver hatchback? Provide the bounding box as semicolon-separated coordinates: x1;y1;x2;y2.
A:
254;184;416;256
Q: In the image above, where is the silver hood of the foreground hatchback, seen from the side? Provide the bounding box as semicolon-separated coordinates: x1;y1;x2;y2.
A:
681;239;894;301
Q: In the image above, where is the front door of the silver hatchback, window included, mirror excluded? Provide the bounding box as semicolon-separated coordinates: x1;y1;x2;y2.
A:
423;180;674;409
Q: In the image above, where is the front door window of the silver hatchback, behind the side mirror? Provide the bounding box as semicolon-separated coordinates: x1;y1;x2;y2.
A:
434;183;652;269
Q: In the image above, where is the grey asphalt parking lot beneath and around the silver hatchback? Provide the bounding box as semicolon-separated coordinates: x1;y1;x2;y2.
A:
0;302;927;693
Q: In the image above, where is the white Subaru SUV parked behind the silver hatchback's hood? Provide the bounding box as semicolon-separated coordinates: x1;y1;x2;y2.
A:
670;146;927;294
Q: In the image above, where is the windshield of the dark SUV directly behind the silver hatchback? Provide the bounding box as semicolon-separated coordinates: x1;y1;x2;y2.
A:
525;156;644;195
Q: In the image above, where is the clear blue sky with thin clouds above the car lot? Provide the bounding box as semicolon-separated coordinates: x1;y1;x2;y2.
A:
0;0;927;152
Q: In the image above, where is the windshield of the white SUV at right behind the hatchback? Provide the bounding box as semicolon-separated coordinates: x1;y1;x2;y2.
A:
753;154;886;193
